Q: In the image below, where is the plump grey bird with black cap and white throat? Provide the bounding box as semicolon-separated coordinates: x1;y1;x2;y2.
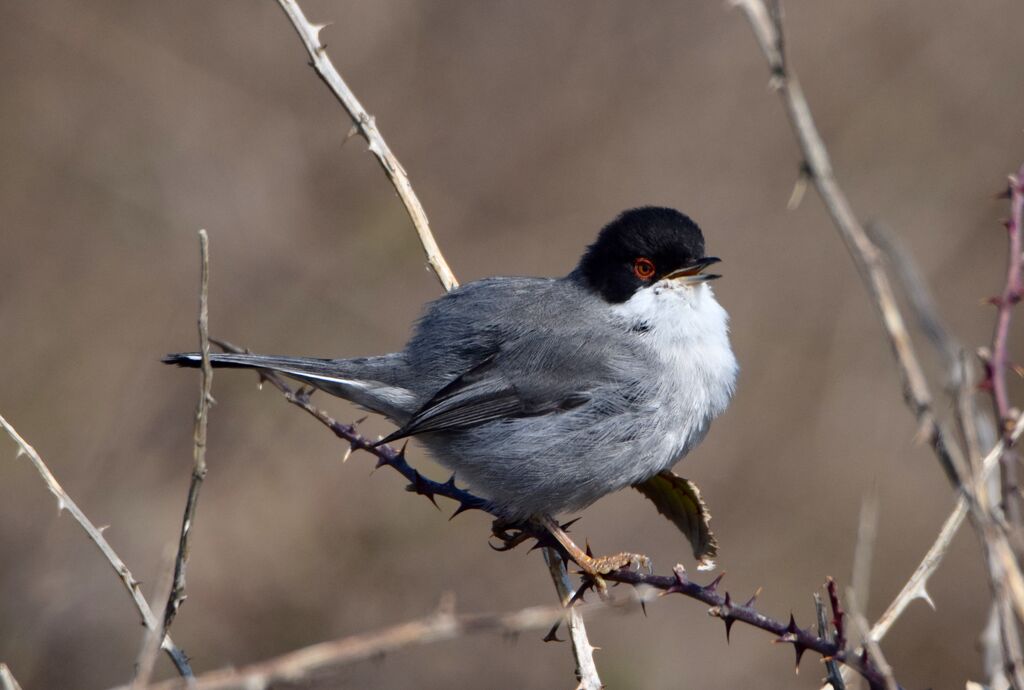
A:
164;206;738;573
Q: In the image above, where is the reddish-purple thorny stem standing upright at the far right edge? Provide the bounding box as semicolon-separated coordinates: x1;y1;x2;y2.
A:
985;165;1024;527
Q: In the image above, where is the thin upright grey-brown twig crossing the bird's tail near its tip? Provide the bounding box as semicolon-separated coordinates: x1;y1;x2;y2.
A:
164;230;213;633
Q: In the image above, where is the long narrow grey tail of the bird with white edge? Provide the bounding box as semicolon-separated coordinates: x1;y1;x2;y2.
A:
163;352;416;424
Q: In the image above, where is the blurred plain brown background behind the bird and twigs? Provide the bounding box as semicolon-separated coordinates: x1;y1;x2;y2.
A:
0;0;1024;690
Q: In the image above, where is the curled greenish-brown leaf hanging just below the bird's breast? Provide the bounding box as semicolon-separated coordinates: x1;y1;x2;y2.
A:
633;470;718;570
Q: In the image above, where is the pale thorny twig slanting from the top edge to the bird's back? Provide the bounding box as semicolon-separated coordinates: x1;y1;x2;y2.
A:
278;0;459;290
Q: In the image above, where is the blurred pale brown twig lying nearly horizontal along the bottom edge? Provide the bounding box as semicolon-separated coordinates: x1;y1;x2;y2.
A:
125;589;630;690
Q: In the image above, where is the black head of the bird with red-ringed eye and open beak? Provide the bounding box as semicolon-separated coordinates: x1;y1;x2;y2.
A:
571;206;718;303
